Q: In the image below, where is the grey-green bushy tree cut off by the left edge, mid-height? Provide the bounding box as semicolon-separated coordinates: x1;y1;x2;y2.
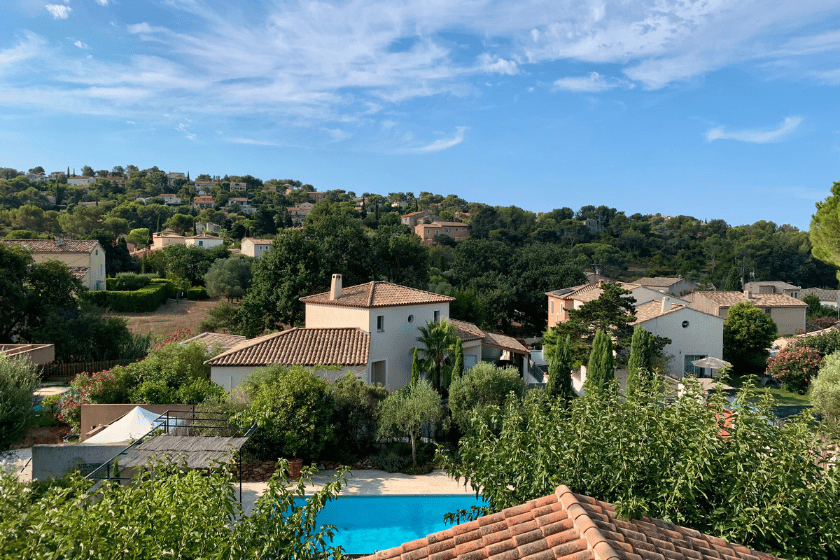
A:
0;351;40;450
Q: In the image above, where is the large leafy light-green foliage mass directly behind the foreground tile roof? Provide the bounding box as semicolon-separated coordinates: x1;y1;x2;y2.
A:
443;381;840;559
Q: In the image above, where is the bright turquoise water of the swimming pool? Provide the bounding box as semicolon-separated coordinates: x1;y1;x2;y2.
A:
298;494;484;554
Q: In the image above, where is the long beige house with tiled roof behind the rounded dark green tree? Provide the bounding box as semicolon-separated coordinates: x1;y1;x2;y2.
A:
685;291;808;335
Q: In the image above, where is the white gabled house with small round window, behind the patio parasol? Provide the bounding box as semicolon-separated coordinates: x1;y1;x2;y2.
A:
633;297;723;379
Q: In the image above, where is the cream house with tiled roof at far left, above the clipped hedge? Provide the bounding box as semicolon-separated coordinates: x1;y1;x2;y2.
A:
0;238;105;290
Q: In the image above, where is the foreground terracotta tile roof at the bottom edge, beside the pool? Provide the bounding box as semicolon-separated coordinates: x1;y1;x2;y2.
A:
363;486;776;560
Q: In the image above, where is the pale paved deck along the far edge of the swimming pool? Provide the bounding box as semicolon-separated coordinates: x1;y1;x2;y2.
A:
235;469;475;514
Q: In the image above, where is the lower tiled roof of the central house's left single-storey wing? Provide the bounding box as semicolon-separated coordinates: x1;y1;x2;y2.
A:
204;328;370;367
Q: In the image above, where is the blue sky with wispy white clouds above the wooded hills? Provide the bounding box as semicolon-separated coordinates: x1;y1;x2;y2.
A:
0;0;840;228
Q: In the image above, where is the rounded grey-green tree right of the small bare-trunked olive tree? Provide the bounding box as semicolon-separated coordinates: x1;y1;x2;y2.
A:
449;362;525;433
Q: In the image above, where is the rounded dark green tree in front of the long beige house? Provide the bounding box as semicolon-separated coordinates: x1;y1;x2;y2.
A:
723;301;778;374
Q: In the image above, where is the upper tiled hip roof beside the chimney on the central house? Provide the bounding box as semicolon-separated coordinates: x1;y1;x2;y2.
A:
300;282;455;309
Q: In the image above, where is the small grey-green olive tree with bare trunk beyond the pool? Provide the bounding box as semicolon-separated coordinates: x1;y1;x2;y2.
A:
379;380;444;467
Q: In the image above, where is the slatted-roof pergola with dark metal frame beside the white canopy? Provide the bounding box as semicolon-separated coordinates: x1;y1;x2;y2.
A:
85;410;257;500
